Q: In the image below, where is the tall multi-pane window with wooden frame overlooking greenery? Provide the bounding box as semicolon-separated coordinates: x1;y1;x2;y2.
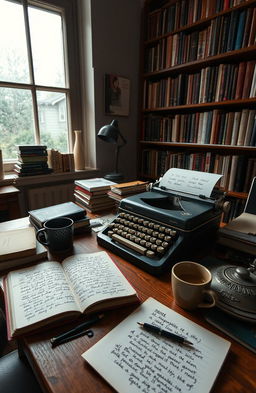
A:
0;0;81;160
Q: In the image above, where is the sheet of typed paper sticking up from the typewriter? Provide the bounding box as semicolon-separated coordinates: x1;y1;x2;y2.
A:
159;168;222;198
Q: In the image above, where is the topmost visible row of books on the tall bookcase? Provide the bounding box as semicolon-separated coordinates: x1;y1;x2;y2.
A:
146;0;246;40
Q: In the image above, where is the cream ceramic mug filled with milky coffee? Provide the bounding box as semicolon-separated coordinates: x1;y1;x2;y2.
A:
172;261;215;310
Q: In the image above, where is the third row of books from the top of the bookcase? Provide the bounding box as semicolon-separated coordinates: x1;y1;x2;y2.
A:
143;61;256;109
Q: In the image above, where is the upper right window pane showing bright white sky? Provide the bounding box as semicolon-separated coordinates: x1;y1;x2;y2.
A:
28;7;65;87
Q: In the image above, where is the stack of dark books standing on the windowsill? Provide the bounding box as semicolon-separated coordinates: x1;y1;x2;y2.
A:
14;145;52;176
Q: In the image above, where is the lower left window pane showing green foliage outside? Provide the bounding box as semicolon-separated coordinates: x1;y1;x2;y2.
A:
0;87;35;159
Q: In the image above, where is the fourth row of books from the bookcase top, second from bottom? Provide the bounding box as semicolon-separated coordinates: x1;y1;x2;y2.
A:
142;109;256;146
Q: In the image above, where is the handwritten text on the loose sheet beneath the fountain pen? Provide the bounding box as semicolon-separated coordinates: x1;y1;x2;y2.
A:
110;309;213;393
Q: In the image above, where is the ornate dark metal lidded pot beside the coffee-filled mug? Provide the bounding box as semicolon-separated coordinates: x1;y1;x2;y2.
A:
211;265;256;322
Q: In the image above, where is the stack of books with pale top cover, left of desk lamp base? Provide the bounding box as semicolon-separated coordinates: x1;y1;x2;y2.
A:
74;178;116;213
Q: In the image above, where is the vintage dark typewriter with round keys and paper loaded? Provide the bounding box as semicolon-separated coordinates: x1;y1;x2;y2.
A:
97;168;227;275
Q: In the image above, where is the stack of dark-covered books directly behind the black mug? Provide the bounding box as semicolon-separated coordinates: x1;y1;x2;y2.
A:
28;202;91;234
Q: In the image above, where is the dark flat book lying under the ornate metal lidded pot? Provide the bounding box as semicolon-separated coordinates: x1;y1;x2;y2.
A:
205;308;256;353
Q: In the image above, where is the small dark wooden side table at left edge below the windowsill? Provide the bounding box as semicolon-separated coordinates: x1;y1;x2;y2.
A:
0;186;21;222
